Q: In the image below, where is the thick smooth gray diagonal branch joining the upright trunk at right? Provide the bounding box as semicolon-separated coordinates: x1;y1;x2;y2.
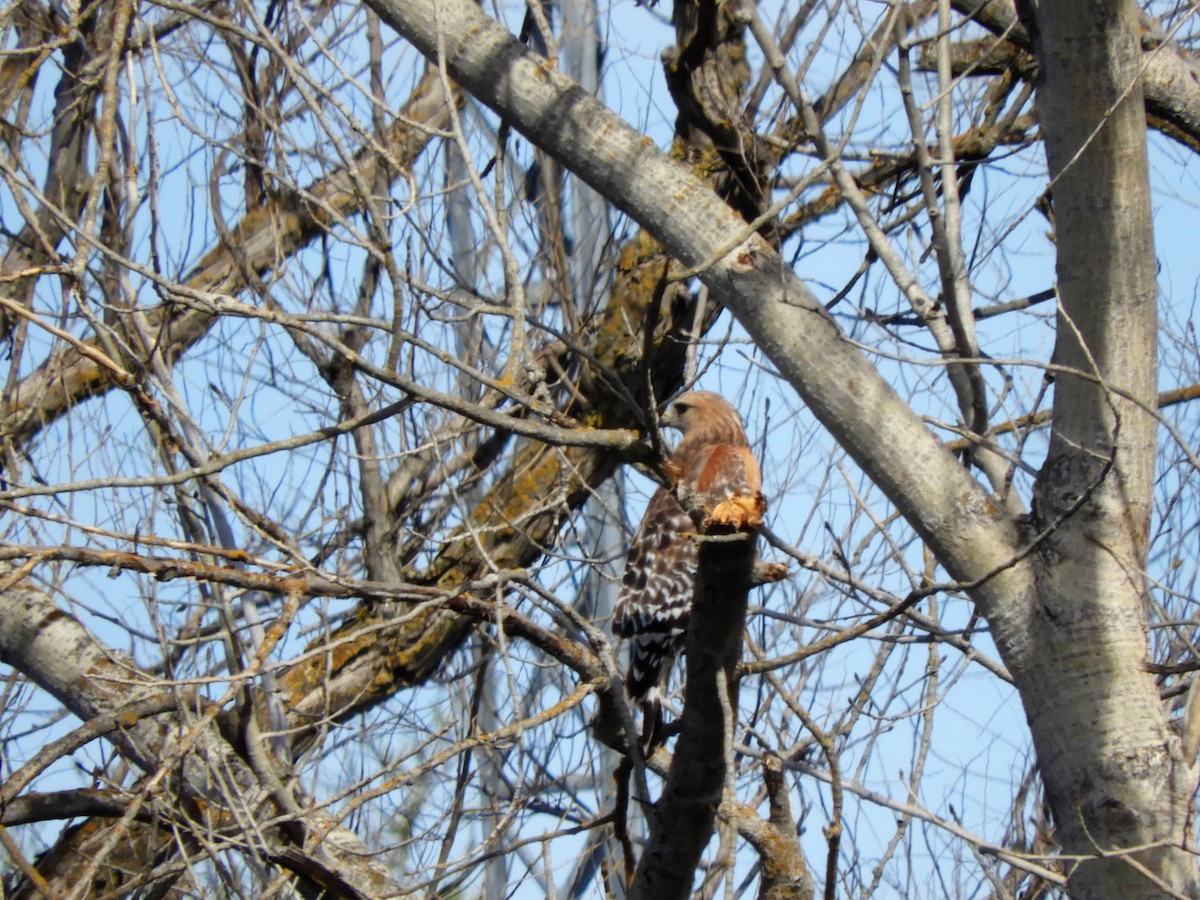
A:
371;0;1016;595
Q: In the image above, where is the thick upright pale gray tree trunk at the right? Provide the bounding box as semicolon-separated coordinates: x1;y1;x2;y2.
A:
1022;0;1200;899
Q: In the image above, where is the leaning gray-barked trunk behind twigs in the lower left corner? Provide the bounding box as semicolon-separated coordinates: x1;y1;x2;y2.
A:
0;571;400;898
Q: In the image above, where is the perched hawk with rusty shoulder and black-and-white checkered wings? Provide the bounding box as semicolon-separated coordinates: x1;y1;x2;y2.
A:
612;391;766;752
